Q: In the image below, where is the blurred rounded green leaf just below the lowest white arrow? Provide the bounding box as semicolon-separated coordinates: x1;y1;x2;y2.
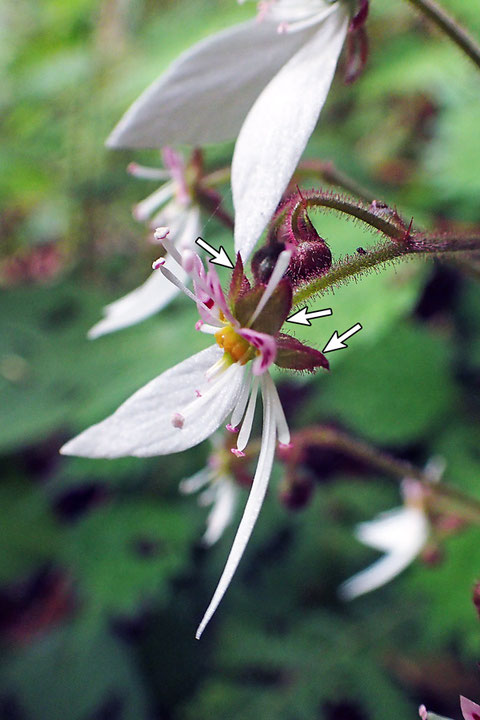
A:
306;323;455;444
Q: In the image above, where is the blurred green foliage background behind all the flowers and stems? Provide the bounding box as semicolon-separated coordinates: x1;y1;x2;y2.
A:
0;0;480;720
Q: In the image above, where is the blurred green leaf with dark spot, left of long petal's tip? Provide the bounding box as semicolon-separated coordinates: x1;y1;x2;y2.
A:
60;497;196;614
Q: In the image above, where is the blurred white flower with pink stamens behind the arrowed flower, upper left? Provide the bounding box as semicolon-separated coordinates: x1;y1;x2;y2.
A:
88;147;200;339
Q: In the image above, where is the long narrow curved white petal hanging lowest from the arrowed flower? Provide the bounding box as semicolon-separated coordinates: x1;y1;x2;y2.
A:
196;380;276;639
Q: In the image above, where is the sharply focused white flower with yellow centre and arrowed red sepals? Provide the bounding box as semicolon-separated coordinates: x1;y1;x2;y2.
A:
61;232;328;637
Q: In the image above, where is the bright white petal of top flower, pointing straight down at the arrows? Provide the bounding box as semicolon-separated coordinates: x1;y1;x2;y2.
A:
232;3;349;260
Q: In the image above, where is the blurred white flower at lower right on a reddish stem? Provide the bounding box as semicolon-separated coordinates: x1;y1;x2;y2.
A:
339;458;445;600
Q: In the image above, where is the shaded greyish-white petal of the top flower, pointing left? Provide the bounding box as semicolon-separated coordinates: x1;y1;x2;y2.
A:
107;20;312;148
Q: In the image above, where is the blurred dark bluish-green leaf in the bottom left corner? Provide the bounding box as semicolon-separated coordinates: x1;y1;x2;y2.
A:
0;621;147;720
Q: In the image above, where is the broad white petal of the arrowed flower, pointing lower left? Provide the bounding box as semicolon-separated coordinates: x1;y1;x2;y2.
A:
61;345;244;458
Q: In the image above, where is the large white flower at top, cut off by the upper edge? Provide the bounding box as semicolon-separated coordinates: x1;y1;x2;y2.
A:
107;0;349;259
